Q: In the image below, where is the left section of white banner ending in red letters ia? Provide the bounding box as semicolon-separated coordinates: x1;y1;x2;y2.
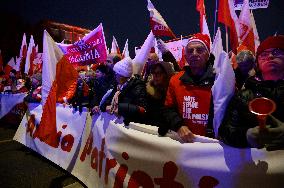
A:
14;103;87;170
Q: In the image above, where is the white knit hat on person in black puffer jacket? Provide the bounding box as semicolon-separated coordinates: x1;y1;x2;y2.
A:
113;57;133;78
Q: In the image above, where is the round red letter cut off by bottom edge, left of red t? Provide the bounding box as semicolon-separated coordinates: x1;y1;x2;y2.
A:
128;170;154;188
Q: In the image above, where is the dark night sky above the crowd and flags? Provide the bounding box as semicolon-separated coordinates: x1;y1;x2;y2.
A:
0;0;284;58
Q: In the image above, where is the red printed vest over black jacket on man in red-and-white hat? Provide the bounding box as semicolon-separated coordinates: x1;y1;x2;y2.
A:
159;63;215;136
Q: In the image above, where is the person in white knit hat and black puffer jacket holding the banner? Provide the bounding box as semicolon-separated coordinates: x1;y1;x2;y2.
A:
100;57;147;125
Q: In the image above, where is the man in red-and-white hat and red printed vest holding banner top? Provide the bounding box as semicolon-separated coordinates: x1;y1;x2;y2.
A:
159;33;215;142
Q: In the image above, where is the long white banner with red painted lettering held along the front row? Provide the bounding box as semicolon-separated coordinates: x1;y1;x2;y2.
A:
14;106;284;188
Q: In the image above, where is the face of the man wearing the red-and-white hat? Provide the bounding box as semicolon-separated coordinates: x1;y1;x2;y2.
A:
185;41;209;74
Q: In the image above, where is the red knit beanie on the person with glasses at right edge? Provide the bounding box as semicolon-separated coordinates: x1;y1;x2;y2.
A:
256;35;284;56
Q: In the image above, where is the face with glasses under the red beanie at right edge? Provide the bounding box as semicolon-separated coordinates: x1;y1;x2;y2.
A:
258;48;284;81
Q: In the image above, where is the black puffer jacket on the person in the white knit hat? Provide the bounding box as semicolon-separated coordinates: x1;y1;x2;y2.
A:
101;75;147;125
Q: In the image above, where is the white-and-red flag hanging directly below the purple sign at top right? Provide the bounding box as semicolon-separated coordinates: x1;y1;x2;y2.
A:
238;0;255;53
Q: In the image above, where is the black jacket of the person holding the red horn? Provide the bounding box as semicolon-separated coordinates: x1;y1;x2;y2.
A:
219;77;284;147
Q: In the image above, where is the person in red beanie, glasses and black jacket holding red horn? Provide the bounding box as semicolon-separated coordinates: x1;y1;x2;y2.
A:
219;35;284;150
